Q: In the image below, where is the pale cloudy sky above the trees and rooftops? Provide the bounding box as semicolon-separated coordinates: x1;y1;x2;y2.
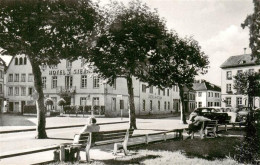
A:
2;0;253;86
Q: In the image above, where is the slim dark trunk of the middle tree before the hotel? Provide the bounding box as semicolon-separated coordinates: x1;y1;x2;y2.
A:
126;76;137;129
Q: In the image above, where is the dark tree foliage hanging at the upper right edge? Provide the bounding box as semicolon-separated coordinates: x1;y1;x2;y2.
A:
242;0;260;62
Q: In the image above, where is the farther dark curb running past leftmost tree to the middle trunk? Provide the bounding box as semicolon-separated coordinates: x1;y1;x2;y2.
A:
0;121;129;134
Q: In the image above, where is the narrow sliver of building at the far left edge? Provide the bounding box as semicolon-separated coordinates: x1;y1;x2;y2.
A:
0;58;6;112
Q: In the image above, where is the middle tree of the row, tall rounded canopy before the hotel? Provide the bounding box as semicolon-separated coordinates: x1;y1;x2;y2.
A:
91;1;166;128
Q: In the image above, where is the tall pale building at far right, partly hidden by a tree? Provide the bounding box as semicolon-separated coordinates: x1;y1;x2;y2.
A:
220;54;260;108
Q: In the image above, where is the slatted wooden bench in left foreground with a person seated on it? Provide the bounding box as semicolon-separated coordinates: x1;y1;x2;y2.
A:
71;129;134;162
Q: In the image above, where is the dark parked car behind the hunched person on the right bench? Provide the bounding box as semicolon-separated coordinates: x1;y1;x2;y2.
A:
191;107;230;124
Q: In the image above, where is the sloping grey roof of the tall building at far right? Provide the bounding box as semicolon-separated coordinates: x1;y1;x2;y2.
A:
220;54;257;68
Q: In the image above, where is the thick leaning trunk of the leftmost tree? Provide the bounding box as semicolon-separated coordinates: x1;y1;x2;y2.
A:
30;58;48;139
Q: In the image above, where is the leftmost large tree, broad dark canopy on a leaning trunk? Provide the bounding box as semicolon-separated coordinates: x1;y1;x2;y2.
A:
0;0;99;138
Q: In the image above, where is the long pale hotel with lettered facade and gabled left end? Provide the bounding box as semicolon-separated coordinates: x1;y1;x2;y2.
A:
5;55;180;116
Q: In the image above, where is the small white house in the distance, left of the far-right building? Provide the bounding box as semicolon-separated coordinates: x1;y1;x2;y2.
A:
193;80;221;107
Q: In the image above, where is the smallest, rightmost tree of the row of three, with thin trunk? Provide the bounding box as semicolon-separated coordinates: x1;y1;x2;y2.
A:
148;32;209;124
